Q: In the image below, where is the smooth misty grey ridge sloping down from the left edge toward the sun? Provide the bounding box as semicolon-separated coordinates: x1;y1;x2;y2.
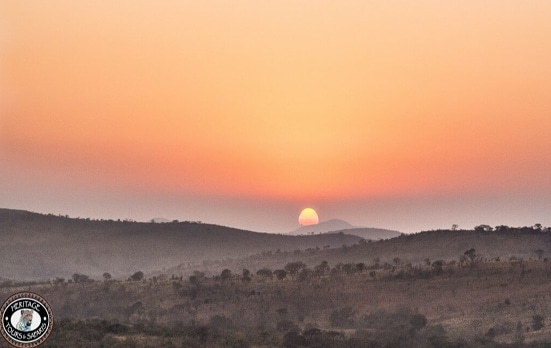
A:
0;209;360;280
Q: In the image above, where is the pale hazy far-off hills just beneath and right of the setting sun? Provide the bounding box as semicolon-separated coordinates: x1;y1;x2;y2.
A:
290;219;401;240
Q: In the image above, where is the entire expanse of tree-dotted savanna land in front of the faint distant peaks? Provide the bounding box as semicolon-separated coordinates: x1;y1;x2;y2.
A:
0;210;551;348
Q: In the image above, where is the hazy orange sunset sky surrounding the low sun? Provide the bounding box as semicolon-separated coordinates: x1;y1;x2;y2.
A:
0;0;551;232
